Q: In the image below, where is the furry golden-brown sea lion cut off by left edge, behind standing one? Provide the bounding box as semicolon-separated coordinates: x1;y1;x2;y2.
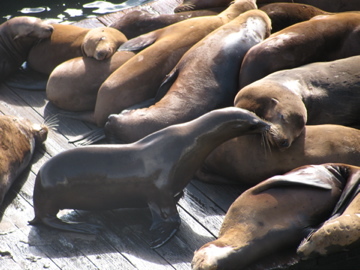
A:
0;115;48;205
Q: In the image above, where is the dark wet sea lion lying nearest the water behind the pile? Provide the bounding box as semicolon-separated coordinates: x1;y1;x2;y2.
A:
109;6;226;39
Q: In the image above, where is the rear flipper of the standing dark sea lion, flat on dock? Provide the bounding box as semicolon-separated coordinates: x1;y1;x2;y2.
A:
29;216;100;234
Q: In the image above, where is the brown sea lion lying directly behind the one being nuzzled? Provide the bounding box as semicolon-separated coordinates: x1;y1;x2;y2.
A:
239;12;360;89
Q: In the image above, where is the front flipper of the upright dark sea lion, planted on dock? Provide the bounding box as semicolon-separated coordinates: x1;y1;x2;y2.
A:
148;197;181;248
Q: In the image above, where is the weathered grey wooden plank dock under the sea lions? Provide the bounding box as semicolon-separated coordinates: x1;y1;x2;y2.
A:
0;81;248;270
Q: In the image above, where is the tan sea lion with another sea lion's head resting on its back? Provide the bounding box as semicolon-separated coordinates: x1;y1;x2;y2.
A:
46;51;135;111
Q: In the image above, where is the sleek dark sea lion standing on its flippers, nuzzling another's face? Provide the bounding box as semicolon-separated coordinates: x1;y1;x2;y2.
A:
31;107;269;248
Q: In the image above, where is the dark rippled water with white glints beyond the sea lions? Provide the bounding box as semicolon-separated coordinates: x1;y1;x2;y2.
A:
0;0;149;23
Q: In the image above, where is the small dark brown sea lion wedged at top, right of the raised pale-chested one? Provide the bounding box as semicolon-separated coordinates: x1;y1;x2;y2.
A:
260;3;329;33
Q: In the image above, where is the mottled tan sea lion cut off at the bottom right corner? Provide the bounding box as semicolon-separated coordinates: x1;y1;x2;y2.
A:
297;166;360;259
